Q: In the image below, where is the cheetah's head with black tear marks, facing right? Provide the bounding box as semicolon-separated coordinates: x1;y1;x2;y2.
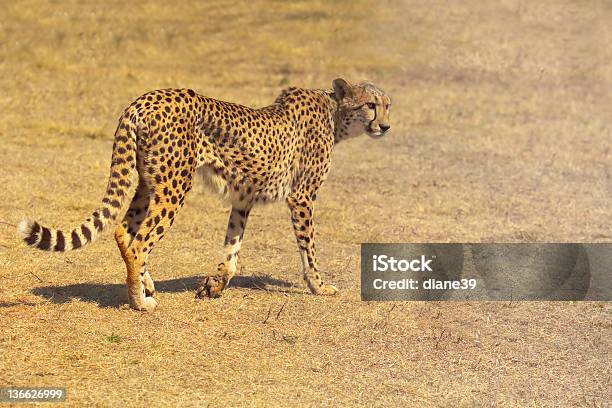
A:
332;78;391;139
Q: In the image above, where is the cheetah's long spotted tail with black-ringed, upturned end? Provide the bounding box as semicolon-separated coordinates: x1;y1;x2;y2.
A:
18;109;138;252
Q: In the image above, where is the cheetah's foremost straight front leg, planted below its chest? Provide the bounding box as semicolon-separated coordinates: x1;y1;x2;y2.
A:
287;194;338;295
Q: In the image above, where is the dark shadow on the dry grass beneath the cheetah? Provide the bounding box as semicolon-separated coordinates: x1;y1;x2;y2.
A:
29;276;293;307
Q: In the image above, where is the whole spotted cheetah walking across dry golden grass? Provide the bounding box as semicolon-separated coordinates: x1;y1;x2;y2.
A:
19;78;391;311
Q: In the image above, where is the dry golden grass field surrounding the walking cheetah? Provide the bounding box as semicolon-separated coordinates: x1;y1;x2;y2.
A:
0;0;612;407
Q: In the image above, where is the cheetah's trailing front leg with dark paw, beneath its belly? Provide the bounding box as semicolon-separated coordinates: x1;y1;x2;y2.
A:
196;207;249;298
